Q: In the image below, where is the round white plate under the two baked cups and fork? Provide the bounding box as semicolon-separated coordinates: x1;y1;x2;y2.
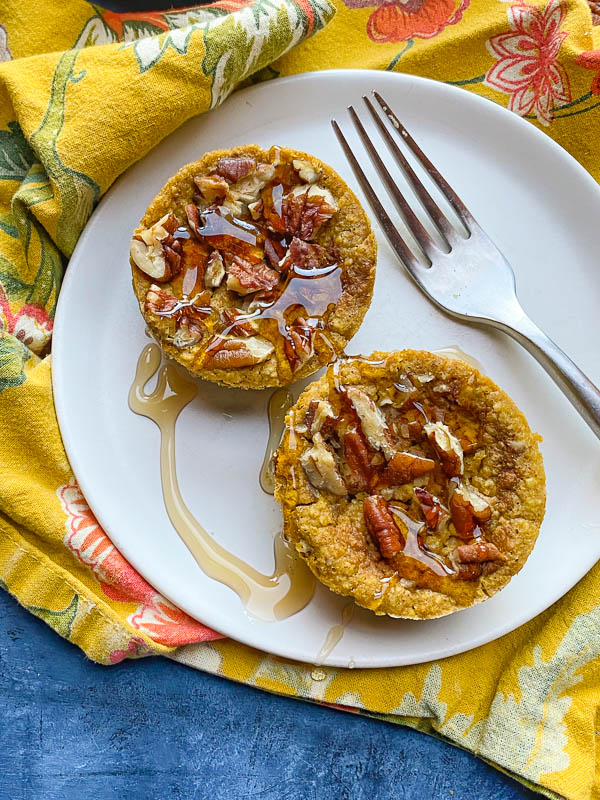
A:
53;70;600;667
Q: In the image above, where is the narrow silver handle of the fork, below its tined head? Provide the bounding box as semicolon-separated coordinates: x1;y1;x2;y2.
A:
494;307;600;439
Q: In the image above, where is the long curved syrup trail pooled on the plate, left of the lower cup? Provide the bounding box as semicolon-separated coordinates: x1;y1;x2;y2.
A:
129;344;315;621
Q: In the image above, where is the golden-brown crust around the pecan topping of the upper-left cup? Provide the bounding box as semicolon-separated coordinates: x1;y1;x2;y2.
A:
130;145;377;389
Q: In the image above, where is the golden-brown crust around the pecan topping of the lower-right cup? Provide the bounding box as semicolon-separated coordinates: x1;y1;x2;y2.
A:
275;350;545;619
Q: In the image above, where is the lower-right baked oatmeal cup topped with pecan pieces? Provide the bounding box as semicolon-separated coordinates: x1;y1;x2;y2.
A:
275;350;545;619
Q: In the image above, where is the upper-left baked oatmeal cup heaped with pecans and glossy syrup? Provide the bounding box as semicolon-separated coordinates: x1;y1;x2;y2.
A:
130;145;377;389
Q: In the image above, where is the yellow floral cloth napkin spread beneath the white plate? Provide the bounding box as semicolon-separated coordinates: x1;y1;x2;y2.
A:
0;0;600;800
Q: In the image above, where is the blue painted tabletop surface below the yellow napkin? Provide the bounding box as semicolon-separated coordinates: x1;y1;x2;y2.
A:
0;591;538;800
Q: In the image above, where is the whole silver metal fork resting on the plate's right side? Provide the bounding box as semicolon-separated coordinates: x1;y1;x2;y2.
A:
331;92;600;438
